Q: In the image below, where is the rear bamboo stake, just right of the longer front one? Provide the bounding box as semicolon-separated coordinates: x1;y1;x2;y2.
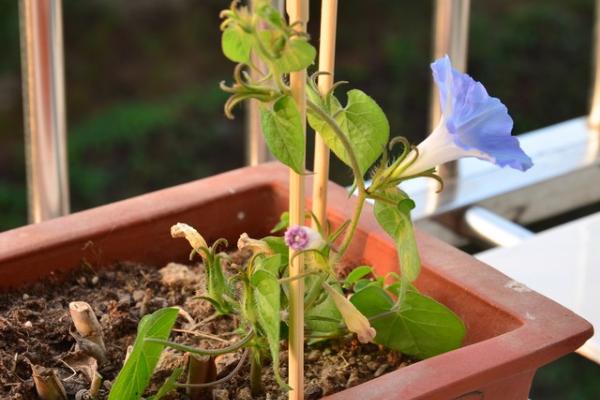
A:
312;0;338;228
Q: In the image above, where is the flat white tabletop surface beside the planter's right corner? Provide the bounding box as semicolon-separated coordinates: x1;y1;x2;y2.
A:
476;211;600;364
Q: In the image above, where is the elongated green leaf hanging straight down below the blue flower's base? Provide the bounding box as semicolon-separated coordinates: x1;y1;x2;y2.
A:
373;188;421;282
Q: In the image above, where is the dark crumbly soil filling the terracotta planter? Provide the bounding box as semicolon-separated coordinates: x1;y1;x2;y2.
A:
0;263;408;400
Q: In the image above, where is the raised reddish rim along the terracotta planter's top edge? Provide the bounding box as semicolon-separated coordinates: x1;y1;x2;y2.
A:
0;163;593;399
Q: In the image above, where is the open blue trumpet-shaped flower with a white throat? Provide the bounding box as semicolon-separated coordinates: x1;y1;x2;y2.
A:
397;56;533;176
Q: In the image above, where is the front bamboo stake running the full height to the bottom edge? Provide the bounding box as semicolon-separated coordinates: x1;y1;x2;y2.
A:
286;0;308;400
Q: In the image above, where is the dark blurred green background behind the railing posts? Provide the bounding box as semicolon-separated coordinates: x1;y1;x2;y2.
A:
0;0;600;399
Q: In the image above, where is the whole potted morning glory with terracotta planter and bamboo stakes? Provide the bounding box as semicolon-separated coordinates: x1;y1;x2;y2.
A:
0;2;592;399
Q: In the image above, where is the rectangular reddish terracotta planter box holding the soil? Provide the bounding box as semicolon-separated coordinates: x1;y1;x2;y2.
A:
0;164;592;400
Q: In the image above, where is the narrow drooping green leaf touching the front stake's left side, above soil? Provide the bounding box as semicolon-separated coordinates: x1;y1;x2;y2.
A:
250;255;288;388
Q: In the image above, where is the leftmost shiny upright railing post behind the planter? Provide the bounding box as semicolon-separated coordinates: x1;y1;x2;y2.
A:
19;0;69;222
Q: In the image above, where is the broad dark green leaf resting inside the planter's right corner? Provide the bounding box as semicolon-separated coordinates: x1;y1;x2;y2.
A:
350;286;466;359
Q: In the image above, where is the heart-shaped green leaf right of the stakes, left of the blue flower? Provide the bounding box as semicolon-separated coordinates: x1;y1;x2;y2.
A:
308;89;390;175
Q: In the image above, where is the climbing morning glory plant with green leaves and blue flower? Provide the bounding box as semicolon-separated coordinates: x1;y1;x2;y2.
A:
111;1;532;400
